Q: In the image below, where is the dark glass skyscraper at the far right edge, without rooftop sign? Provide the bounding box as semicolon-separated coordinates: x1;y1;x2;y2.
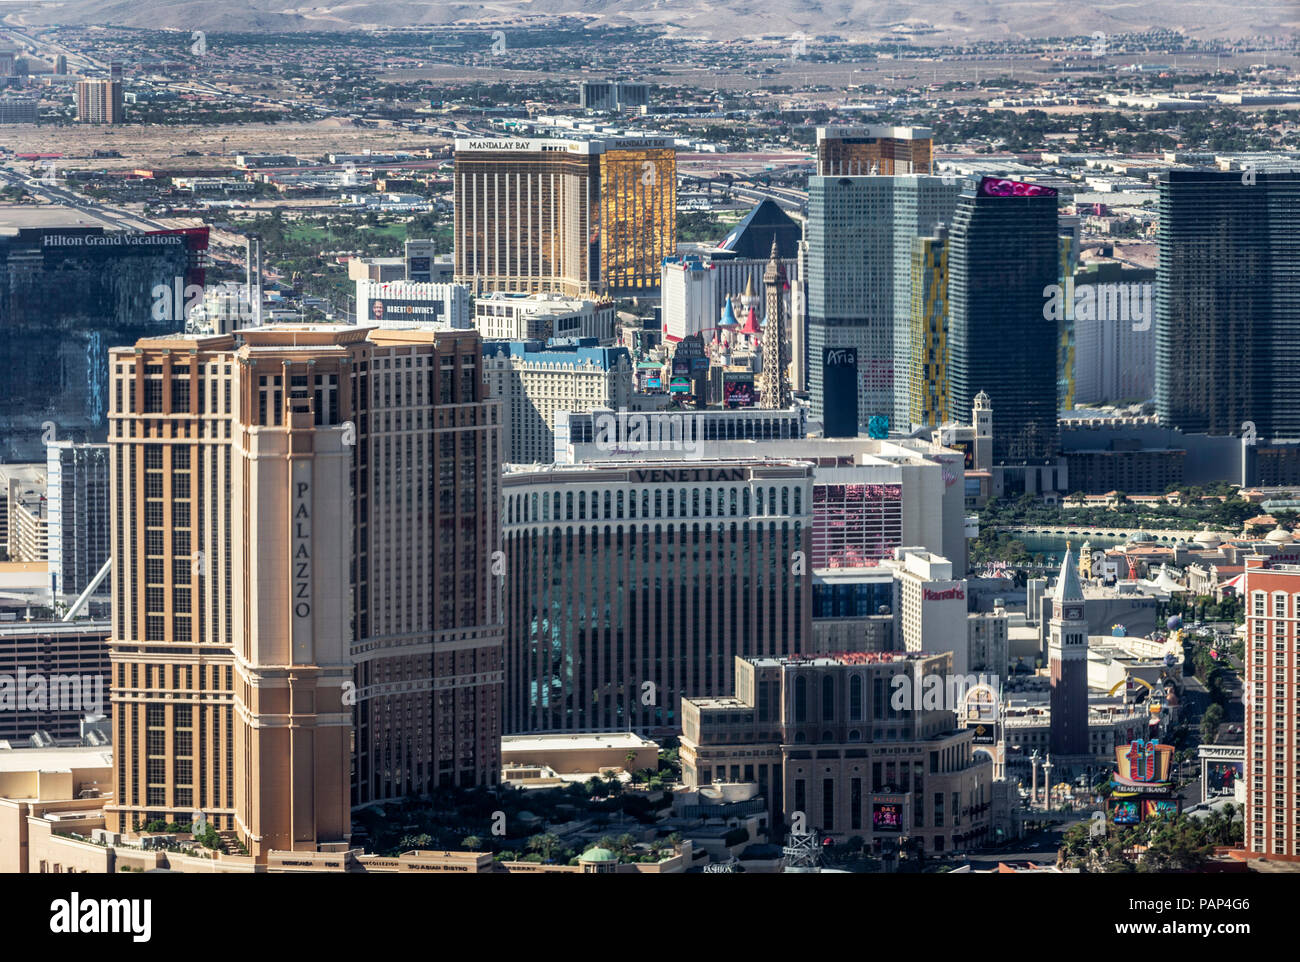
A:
1154;170;1300;438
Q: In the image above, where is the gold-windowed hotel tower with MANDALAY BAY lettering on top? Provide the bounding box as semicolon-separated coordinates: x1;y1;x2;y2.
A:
454;138;677;296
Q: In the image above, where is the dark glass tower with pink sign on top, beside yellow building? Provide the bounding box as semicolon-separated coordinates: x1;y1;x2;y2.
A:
948;177;1058;463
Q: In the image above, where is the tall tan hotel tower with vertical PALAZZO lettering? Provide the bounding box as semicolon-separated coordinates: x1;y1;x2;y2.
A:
108;325;502;859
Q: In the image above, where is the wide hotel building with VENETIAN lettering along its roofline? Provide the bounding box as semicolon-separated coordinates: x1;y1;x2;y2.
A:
502;459;813;733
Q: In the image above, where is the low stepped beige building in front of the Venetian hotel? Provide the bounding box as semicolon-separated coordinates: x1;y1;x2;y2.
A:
681;651;992;853
